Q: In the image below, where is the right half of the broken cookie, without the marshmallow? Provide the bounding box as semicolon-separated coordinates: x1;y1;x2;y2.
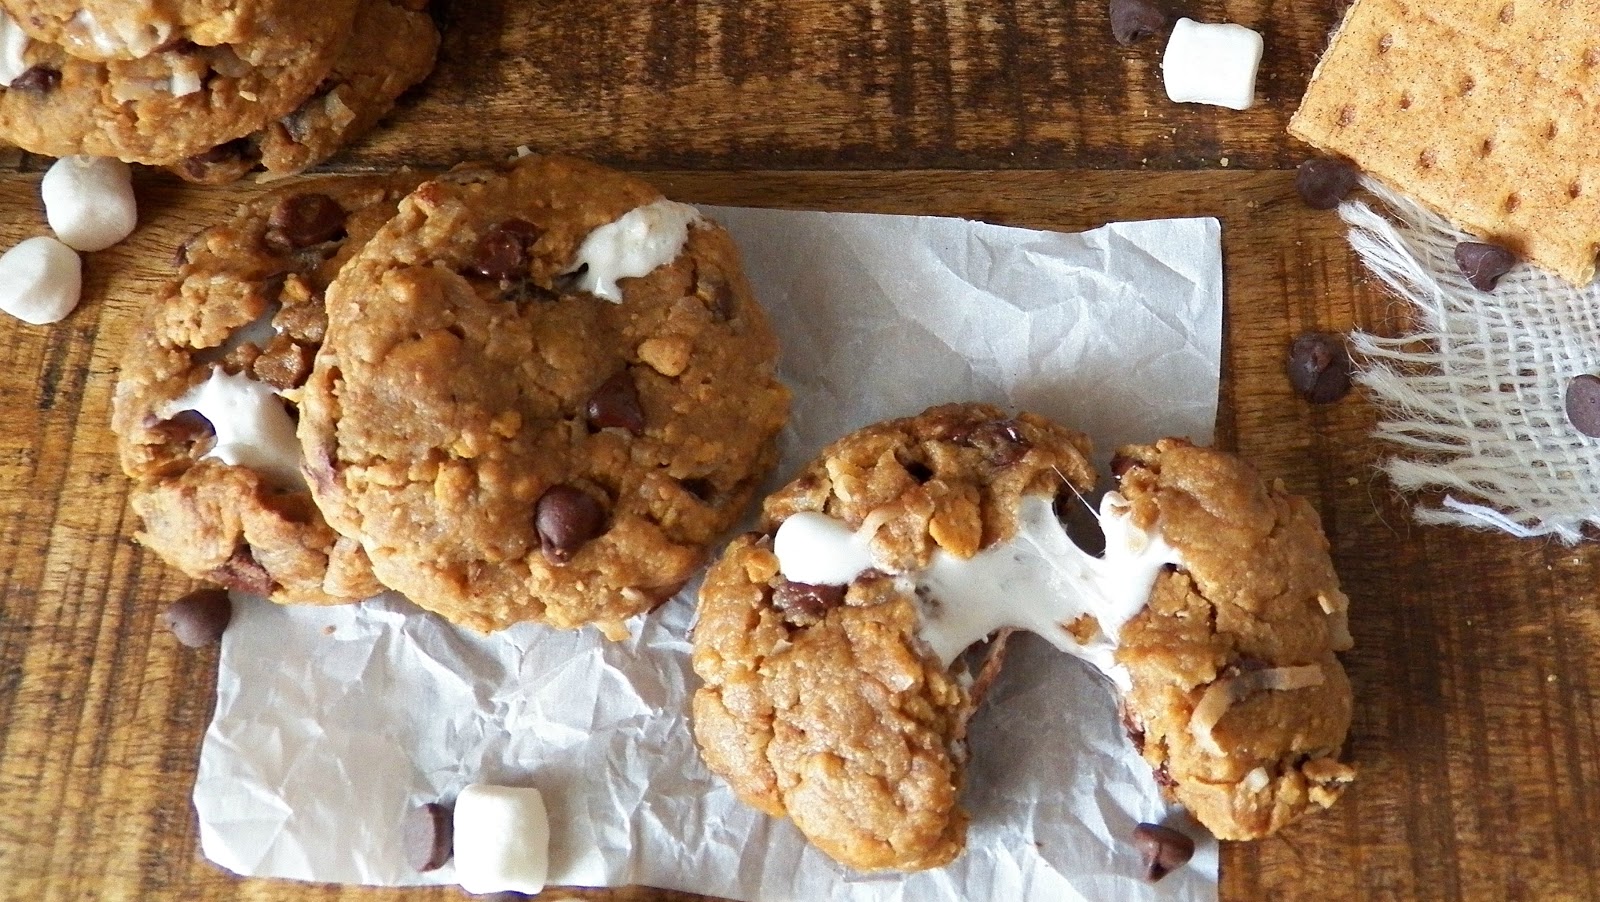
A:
1114;440;1355;840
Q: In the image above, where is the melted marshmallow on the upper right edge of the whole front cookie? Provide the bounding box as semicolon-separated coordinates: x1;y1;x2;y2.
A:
568;200;701;304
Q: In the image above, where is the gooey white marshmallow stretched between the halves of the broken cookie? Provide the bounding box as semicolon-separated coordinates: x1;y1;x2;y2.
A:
773;493;1182;691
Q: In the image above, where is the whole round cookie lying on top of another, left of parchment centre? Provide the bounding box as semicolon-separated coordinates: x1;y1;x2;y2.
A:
299;157;789;637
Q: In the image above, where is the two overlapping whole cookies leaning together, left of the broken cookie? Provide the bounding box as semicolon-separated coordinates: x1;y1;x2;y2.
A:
114;157;787;637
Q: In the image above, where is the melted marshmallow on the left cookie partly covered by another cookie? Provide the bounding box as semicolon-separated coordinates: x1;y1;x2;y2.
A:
168;366;306;488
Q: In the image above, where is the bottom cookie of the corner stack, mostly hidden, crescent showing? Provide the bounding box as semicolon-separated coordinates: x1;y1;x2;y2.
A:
170;0;438;184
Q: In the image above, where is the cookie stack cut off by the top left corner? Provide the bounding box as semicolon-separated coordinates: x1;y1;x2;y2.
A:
0;0;438;184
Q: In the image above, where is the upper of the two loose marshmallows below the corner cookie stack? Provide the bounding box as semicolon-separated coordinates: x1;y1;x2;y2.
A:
38;157;139;251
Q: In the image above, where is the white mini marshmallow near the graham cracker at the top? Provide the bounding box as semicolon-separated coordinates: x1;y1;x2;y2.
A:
1162;19;1262;110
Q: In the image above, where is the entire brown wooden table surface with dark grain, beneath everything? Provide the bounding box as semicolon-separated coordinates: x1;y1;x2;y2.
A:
0;0;1600;902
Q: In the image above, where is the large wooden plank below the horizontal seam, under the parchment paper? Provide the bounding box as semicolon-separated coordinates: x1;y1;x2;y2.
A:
0;163;1600;902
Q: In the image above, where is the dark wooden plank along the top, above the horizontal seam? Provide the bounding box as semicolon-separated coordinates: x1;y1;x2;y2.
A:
0;0;1341;178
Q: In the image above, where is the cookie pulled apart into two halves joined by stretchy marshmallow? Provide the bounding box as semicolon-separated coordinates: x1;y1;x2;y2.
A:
693;405;1354;870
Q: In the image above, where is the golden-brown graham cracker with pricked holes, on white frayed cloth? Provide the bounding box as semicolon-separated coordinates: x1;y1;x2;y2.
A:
1290;0;1600;286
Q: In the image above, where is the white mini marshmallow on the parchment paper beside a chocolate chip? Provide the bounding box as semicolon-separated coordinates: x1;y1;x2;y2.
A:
454;784;550;896
